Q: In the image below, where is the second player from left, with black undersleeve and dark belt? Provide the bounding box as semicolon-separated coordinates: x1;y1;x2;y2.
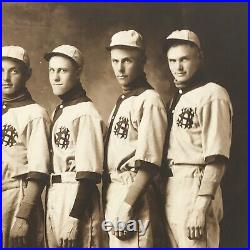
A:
44;45;104;247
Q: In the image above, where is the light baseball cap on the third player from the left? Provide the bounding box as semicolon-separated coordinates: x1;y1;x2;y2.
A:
107;30;144;50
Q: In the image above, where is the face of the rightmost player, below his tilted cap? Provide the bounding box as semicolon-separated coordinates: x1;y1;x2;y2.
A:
167;44;201;87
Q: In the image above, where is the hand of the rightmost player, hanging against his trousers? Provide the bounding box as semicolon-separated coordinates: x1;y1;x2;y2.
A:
186;209;206;240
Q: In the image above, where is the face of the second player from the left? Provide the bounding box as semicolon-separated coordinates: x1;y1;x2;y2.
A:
49;56;80;96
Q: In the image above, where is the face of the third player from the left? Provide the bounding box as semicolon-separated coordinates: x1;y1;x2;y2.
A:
111;48;144;88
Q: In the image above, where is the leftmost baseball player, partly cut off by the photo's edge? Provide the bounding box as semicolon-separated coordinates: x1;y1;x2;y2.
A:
2;46;50;248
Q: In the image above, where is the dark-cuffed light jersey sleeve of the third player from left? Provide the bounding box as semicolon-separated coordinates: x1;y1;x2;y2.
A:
135;101;167;167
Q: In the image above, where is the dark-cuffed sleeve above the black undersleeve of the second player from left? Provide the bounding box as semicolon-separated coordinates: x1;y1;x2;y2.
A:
75;115;105;183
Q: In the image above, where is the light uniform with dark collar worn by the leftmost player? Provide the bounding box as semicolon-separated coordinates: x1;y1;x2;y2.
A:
2;96;50;247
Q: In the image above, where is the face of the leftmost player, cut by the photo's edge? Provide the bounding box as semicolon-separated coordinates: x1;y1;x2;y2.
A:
2;58;28;96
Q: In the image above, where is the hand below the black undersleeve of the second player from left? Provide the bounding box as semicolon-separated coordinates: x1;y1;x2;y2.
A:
60;216;79;248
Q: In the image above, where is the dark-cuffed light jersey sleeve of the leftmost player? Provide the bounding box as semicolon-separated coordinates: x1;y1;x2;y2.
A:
27;114;50;181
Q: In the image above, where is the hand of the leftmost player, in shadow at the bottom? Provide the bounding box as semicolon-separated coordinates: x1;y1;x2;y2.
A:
10;218;29;248
